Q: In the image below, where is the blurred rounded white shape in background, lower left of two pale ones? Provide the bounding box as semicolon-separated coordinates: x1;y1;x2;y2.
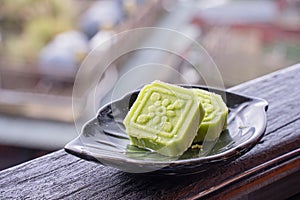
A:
39;31;89;75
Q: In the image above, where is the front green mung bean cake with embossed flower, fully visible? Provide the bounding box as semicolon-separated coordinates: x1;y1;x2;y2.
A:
124;81;205;156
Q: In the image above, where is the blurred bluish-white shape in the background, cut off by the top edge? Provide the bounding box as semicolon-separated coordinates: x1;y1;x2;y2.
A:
79;0;123;38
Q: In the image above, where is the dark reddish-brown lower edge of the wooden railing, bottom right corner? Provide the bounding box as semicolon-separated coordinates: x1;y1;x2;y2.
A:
209;149;300;200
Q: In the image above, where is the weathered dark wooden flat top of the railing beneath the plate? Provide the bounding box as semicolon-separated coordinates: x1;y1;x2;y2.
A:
0;65;300;199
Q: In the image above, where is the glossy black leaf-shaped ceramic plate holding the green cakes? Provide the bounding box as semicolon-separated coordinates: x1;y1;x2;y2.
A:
65;86;268;174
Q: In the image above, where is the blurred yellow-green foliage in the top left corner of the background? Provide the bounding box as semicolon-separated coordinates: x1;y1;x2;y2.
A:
0;0;76;60
